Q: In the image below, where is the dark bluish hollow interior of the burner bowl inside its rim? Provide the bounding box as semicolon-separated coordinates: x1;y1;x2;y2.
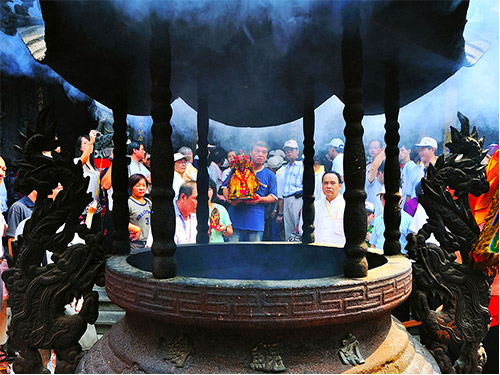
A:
127;242;387;280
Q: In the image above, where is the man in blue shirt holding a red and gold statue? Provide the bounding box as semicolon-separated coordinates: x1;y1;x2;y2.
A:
222;141;278;242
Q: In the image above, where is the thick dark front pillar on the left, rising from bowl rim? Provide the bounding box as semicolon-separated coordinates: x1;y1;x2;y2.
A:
149;15;177;279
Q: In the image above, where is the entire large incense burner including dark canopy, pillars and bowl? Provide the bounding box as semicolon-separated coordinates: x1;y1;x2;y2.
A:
4;0;488;373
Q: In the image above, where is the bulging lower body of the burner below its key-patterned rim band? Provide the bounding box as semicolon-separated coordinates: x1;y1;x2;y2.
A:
77;313;439;374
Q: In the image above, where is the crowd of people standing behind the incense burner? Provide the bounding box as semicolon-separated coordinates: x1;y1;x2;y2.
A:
0;131;498;372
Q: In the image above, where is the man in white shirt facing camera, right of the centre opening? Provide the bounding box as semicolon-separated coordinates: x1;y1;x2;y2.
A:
314;172;345;247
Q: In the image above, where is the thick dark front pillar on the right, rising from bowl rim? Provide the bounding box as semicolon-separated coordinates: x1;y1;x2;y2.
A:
342;2;368;277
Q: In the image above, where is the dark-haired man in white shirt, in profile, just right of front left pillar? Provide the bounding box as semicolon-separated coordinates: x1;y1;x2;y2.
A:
174;181;198;245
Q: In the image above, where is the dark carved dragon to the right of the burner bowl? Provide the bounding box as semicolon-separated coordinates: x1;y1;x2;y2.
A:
406;112;495;373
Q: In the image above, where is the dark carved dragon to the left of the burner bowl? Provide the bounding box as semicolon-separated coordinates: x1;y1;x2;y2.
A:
2;110;105;373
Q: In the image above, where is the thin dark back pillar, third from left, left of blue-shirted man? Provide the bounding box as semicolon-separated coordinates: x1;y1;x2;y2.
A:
196;78;210;244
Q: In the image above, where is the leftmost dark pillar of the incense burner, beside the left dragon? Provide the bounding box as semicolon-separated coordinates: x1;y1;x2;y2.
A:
111;67;130;255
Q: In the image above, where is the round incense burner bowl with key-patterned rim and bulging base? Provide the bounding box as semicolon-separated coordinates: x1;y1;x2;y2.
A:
78;243;439;373
